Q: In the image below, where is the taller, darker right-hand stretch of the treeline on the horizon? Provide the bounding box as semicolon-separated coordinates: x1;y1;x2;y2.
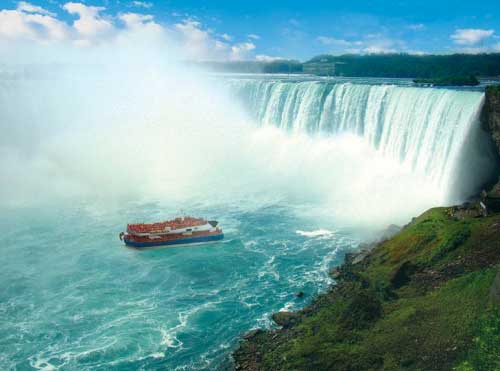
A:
306;53;500;78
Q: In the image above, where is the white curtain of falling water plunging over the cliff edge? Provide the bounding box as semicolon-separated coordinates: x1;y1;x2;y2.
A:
227;79;492;203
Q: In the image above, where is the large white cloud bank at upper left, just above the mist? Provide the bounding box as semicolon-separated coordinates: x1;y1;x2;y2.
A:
0;2;257;60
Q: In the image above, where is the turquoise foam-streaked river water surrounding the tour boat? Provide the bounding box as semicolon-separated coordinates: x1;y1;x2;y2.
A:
0;203;357;370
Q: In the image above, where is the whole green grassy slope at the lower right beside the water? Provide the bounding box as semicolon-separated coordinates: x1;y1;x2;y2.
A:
236;208;500;371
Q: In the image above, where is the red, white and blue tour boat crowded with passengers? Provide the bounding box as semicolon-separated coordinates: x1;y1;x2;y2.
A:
119;216;224;248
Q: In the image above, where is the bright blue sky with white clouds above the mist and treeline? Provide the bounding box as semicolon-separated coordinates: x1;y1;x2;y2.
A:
0;0;500;60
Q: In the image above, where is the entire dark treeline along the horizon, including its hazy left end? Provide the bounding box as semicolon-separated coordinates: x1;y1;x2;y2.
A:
196;53;500;78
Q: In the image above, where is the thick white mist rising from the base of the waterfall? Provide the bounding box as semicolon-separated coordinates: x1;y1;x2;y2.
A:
0;26;450;227
